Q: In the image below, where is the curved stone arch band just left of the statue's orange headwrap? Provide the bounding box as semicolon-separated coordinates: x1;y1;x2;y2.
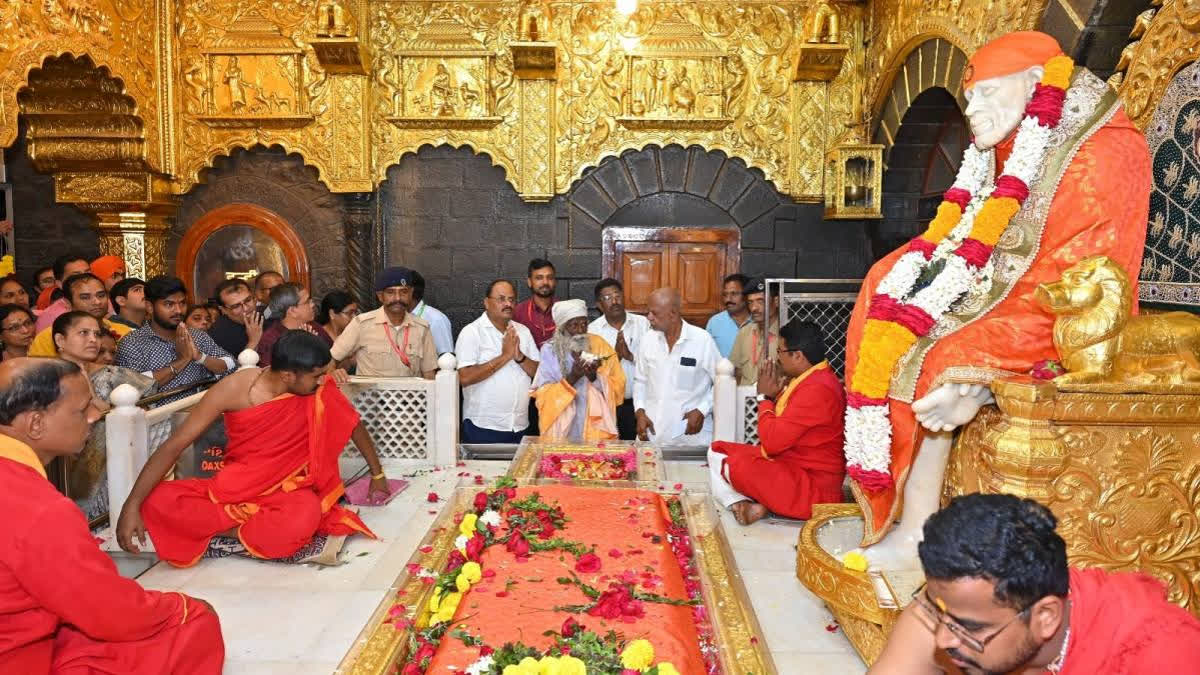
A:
872;37;967;163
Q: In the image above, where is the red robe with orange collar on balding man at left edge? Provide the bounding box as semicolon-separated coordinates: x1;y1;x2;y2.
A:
0;436;224;675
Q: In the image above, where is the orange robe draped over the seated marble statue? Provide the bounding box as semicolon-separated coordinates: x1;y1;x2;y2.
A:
846;109;1151;545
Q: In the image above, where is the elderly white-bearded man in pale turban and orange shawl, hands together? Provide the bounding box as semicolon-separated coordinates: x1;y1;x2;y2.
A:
533;300;625;441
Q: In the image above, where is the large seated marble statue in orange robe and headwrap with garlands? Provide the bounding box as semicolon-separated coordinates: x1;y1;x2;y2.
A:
846;31;1151;557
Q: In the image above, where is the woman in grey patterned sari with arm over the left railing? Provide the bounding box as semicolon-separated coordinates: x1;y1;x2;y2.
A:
52;311;157;520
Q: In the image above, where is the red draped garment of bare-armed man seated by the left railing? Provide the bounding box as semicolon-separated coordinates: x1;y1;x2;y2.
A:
142;378;374;567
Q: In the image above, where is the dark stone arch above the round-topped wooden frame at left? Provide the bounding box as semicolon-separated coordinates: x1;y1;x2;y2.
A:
167;145;348;297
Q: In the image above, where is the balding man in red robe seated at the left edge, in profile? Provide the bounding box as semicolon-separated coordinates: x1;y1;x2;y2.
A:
0;359;224;675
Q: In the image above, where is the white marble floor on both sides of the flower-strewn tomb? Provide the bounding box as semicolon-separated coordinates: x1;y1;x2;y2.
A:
124;454;864;675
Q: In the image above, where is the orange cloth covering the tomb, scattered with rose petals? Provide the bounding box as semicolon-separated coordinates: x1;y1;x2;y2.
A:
427;485;704;674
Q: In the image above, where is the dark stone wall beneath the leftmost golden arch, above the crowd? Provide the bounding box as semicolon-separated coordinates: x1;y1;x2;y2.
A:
4;123;100;283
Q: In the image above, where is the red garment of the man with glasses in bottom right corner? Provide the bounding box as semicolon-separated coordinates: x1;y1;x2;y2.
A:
1062;568;1200;675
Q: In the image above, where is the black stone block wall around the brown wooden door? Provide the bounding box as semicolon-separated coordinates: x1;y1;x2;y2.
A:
378;145;871;330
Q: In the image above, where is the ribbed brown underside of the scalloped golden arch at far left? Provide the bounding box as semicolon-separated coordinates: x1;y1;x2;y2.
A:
17;53;148;172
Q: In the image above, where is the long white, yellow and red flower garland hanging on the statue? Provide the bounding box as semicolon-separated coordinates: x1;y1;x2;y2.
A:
845;55;1075;492
